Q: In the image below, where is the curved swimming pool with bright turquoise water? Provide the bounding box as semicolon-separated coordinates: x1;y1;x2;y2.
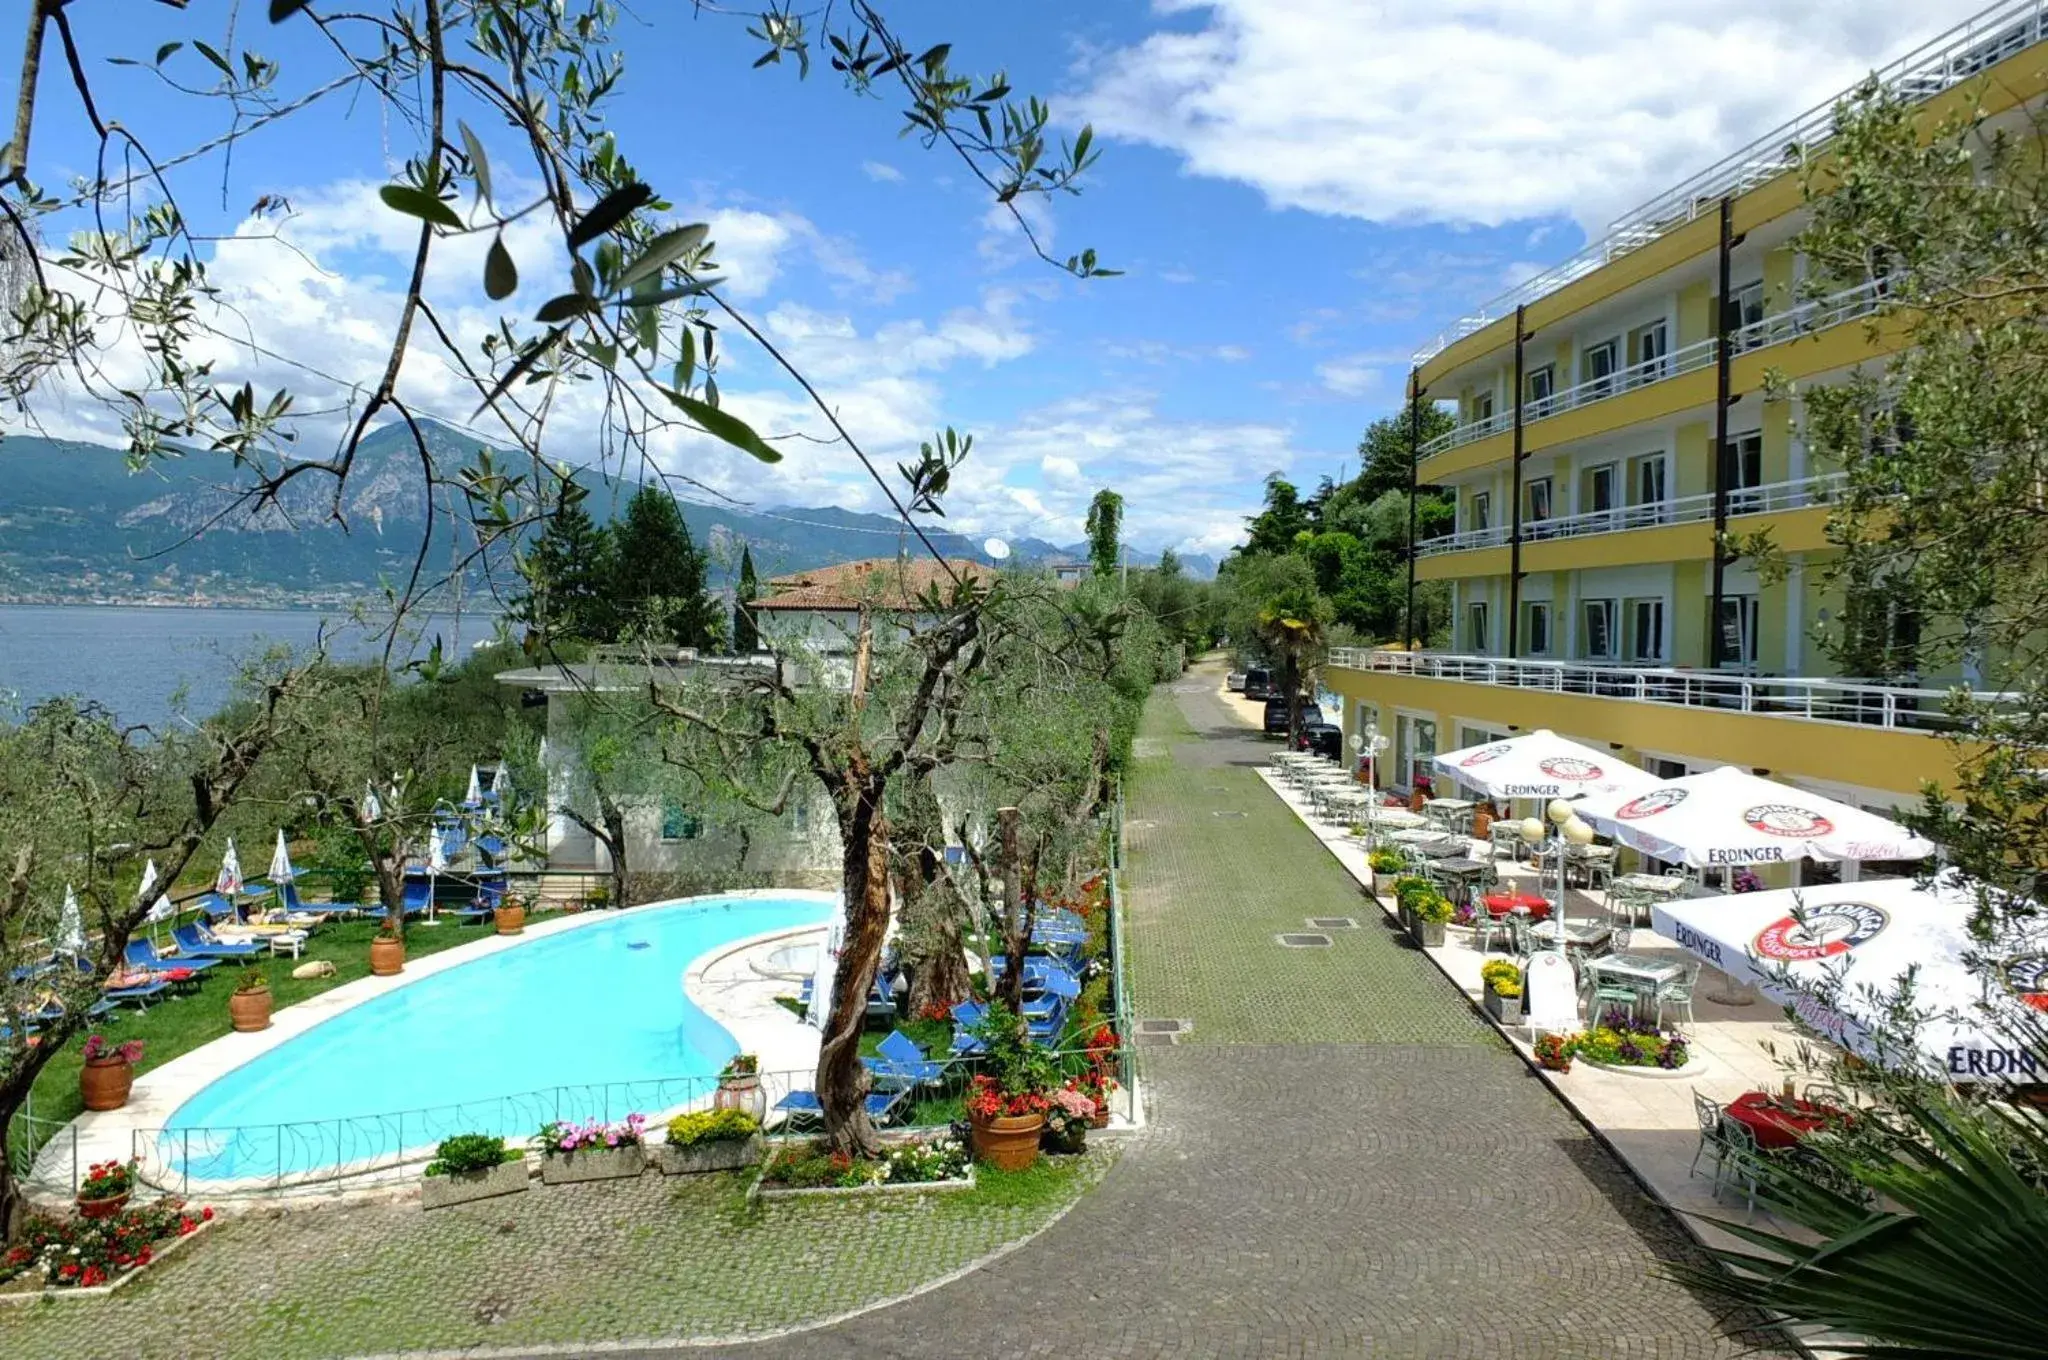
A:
156;895;831;1180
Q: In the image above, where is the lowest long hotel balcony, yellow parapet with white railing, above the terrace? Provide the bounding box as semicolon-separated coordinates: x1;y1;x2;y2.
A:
1323;647;2001;795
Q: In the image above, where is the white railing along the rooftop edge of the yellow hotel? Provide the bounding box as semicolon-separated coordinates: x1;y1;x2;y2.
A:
1415;0;2048;365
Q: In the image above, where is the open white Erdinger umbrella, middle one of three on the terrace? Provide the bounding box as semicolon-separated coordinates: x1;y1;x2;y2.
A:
1579;766;1933;868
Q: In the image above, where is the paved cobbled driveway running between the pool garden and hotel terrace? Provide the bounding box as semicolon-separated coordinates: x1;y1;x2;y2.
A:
724;668;1772;1360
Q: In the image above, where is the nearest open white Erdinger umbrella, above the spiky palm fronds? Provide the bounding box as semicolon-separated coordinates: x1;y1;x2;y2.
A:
1653;873;2048;1081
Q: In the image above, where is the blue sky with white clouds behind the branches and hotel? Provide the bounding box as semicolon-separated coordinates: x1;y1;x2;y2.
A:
8;0;1976;553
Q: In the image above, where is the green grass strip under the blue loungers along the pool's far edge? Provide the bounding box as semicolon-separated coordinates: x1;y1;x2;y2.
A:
31;918;494;1122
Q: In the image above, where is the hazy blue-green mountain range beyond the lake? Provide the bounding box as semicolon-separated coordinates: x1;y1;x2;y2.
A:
0;422;1214;606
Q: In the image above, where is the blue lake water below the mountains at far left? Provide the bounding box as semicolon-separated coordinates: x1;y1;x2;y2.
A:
0;604;492;723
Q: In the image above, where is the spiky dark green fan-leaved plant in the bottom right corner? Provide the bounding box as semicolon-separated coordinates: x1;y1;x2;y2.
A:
1677;1094;2048;1360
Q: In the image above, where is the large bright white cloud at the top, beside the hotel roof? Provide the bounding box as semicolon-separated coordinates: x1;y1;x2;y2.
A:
1073;0;1982;229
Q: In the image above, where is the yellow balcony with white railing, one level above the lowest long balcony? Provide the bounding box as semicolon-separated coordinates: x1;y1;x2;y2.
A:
1415;473;1843;580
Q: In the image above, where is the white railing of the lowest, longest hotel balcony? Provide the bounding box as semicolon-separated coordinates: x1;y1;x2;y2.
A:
1329;647;2007;733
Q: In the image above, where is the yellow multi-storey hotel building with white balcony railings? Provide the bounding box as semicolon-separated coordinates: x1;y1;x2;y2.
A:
1323;0;2048;872
